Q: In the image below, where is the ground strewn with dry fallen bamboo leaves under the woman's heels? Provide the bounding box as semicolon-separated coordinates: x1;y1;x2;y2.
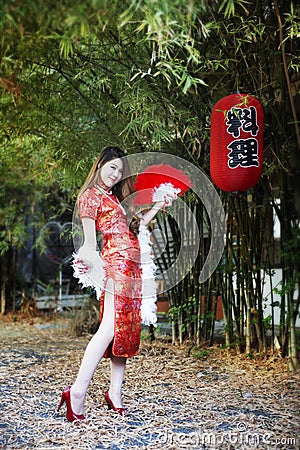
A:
0;318;300;450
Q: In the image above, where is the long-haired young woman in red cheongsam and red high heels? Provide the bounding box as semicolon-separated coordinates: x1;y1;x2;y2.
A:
58;147;175;421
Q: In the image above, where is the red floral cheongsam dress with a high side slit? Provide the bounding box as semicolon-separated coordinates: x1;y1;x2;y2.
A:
79;187;142;357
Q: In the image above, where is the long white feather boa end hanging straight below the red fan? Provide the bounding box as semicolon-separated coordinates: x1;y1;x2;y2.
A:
138;225;157;326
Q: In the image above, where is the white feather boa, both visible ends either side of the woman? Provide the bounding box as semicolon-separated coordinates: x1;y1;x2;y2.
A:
72;225;157;326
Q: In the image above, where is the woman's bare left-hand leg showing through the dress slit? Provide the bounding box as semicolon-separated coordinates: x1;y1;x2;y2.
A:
71;279;115;414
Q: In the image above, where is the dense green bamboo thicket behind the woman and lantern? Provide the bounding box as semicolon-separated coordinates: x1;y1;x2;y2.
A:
0;0;300;368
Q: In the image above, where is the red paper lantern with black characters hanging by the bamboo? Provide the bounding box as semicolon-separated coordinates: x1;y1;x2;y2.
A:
210;94;264;192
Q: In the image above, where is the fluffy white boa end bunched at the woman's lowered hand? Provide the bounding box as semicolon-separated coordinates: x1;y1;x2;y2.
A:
72;247;106;299
